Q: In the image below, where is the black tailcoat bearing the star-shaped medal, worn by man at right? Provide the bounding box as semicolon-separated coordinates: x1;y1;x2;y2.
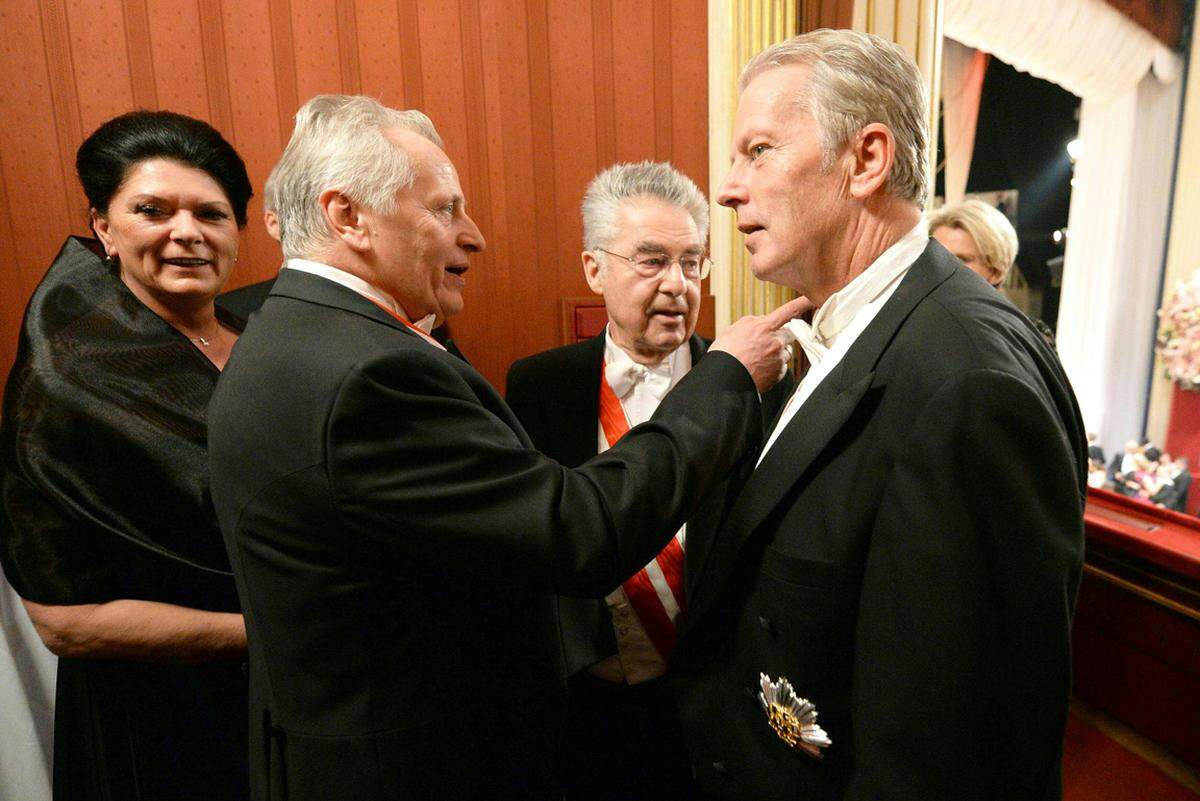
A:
672;242;1086;801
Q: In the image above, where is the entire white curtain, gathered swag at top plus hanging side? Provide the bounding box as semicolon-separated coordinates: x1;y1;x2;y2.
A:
946;0;1182;452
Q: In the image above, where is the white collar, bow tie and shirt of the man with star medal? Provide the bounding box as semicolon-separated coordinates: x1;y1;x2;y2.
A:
758;222;929;464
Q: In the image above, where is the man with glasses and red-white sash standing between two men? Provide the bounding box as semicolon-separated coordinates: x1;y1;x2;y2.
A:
508;162;792;801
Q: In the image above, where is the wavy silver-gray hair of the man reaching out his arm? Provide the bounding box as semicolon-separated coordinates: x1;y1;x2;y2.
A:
272;95;442;259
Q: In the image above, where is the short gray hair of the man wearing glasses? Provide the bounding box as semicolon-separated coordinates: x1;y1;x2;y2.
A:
583;161;708;253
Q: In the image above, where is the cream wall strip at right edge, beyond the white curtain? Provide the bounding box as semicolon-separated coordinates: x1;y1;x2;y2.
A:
1146;26;1200;442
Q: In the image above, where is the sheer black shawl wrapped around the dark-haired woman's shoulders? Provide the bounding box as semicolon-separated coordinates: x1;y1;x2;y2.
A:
0;237;238;612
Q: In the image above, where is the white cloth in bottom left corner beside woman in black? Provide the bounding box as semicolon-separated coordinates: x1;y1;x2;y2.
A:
0;565;58;801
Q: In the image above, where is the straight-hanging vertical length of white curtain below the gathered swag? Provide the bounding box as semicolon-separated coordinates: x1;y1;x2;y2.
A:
1057;76;1182;453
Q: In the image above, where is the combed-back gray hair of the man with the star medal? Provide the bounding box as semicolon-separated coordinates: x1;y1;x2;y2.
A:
738;29;929;207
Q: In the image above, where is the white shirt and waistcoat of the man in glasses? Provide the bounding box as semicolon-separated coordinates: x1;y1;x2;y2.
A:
589;326;691;685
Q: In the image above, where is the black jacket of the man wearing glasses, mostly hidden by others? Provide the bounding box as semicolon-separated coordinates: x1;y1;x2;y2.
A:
505;331;794;674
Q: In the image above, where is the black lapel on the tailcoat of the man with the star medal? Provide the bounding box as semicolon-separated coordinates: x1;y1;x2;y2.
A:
688;241;958;626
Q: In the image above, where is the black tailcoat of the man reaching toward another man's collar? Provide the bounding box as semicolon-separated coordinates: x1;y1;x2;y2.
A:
209;270;761;801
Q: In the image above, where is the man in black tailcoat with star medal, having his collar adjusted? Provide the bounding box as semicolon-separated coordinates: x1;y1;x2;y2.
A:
672;31;1086;801
